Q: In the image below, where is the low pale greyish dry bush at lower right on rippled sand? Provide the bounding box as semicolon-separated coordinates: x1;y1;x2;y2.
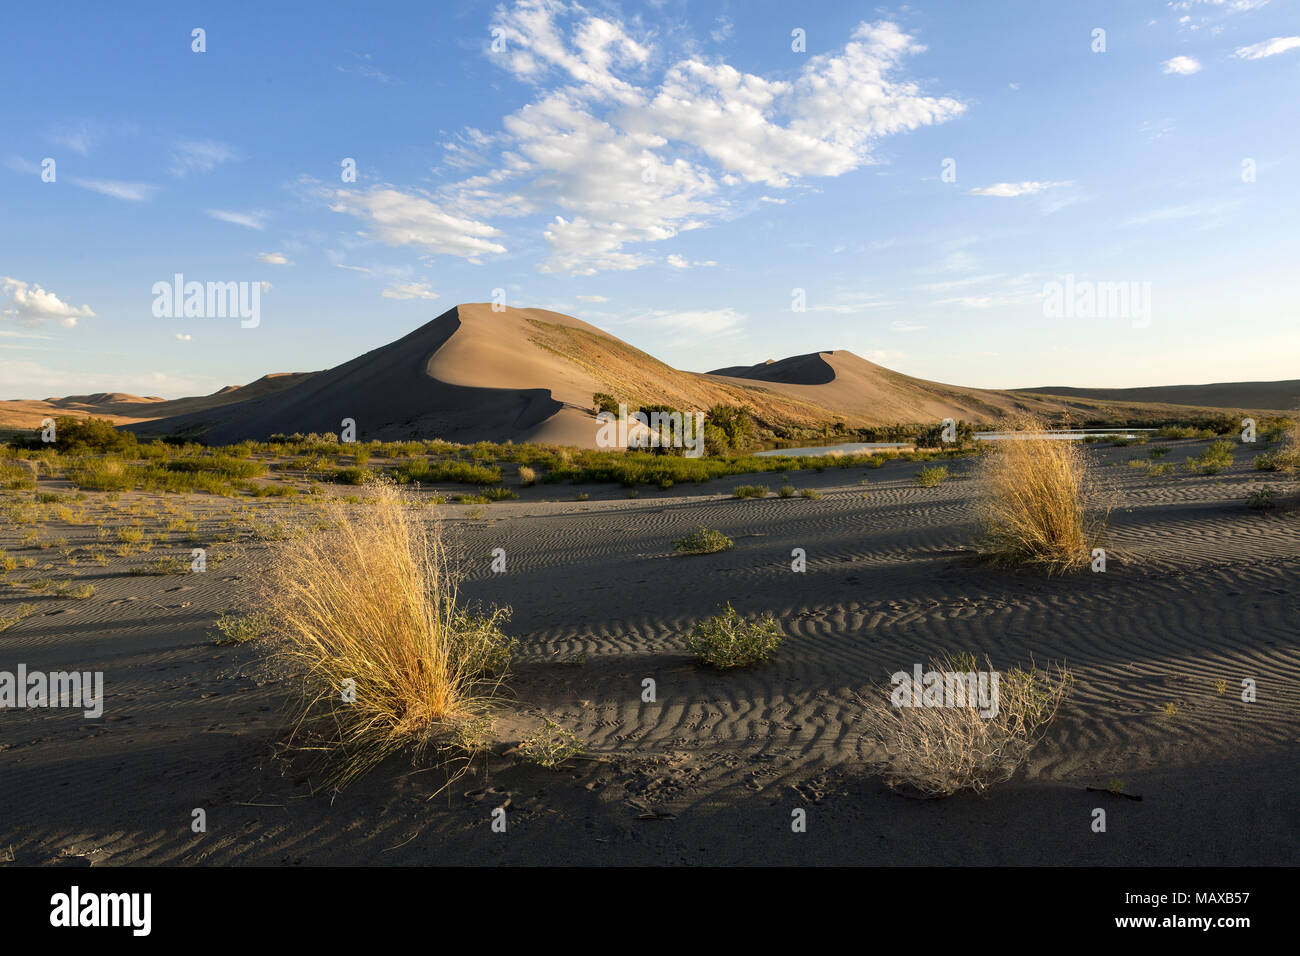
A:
866;657;1074;797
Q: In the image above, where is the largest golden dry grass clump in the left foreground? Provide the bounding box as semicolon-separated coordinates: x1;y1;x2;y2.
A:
267;481;511;787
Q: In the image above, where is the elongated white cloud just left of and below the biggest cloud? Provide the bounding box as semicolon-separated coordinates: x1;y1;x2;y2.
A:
330;189;506;261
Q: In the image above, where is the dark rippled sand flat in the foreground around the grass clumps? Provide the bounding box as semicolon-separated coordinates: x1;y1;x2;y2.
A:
0;442;1300;865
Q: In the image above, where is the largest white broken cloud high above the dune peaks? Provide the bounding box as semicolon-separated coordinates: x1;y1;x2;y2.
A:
436;0;965;274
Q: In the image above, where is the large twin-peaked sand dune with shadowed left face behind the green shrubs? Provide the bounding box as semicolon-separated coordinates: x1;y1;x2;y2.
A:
116;303;1284;447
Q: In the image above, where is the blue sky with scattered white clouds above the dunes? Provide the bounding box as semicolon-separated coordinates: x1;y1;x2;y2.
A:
0;0;1300;398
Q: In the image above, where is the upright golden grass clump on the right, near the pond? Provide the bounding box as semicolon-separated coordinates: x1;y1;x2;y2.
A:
978;420;1110;571
